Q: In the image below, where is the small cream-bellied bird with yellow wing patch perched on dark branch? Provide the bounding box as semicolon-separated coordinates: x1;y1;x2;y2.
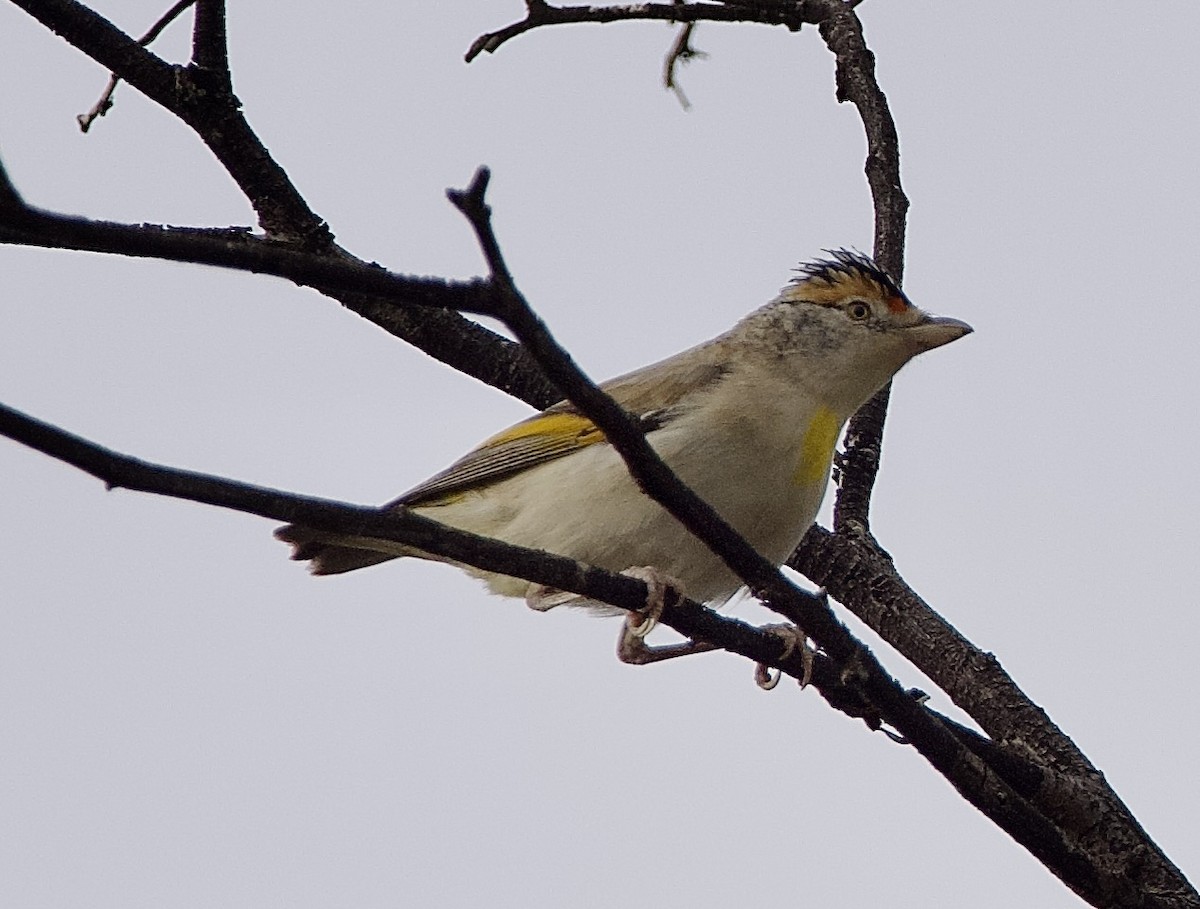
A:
276;249;971;657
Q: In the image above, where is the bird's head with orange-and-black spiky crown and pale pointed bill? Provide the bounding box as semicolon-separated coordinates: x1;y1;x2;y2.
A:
734;249;971;413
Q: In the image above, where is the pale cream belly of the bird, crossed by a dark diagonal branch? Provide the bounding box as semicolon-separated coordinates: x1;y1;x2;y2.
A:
419;424;828;602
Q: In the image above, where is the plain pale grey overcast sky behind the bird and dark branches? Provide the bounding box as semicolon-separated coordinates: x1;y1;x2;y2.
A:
0;0;1200;909
